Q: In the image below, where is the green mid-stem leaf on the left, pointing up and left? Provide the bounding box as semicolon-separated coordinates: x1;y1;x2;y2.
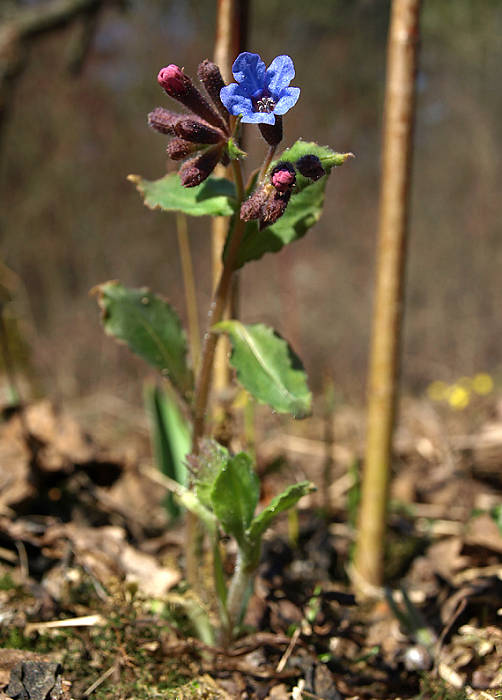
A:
93;281;193;396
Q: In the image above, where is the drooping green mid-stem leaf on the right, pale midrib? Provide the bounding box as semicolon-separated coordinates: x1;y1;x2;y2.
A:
212;321;312;418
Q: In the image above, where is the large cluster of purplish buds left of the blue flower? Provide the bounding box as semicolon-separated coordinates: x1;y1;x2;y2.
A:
148;60;230;187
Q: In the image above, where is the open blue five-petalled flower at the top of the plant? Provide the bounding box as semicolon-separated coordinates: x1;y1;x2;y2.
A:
220;51;300;124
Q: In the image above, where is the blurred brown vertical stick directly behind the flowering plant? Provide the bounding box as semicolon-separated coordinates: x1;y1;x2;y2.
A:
211;0;249;412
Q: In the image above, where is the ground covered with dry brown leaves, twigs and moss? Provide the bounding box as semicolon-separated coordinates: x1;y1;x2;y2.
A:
0;397;502;700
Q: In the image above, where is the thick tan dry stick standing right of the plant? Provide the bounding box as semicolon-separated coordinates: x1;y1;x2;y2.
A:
354;0;420;593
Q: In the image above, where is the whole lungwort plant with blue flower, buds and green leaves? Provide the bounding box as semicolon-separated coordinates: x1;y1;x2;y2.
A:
94;52;351;642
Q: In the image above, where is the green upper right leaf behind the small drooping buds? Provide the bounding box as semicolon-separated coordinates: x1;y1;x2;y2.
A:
233;140;352;267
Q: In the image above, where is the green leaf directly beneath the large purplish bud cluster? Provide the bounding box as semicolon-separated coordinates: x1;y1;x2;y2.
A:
127;173;236;216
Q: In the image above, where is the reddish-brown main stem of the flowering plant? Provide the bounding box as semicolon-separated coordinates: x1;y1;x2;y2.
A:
193;160;245;454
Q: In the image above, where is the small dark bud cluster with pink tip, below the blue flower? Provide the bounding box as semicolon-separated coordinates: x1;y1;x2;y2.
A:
240;154;326;231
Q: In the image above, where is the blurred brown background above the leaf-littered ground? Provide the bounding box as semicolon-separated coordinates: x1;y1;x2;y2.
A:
0;0;502;404
